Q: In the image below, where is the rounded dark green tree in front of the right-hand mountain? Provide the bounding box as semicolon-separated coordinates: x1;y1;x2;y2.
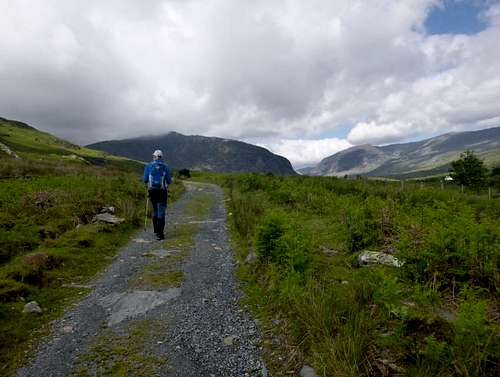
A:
450;150;488;188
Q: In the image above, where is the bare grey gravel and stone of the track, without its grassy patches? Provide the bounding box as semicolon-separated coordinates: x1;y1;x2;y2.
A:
18;183;267;377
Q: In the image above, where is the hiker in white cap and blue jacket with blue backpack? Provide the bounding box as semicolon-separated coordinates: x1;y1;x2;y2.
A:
144;149;172;240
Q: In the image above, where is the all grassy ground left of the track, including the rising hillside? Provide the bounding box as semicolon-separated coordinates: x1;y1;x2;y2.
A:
0;119;186;375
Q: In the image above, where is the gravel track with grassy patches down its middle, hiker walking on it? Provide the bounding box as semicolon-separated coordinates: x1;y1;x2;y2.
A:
18;183;265;376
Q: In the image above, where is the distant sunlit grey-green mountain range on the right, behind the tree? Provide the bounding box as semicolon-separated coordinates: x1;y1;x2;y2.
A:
305;127;500;178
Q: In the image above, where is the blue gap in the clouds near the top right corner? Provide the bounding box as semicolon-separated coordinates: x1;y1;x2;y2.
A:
425;0;497;35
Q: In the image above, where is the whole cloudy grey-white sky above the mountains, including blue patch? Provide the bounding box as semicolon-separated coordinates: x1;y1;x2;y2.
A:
0;0;500;167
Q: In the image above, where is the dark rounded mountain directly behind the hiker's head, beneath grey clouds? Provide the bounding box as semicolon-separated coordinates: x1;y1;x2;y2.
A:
87;132;295;175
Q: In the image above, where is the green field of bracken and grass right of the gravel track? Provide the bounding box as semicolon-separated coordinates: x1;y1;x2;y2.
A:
194;174;500;376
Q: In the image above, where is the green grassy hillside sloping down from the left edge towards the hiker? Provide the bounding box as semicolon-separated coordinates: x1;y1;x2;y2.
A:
0;117;144;170
